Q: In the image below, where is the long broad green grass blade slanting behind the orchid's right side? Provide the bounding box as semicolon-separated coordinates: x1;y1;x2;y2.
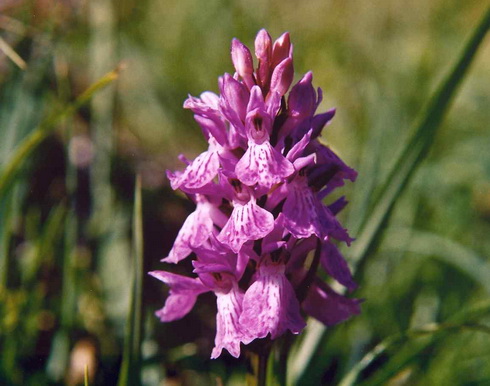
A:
289;8;490;384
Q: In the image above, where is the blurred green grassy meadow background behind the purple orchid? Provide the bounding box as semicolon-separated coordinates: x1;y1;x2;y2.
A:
0;0;490;386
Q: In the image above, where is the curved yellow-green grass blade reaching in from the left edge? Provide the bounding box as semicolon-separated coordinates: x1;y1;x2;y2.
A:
0;67;120;197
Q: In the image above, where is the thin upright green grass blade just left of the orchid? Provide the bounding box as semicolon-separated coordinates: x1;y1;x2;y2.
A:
118;176;143;386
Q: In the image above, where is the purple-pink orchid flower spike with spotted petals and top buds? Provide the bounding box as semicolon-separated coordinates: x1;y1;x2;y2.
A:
150;30;360;358
